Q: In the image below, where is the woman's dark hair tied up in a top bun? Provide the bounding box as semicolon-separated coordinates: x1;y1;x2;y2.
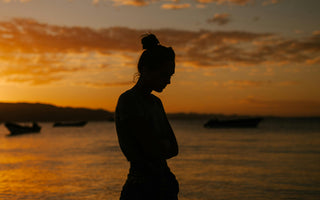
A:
138;34;175;73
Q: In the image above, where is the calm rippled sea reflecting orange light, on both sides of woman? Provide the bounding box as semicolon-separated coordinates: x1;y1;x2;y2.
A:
0;119;320;200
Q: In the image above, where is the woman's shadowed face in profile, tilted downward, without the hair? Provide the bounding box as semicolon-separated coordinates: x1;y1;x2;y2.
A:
146;61;175;92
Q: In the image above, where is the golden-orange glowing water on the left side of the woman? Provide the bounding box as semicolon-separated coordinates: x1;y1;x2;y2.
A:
0;123;126;200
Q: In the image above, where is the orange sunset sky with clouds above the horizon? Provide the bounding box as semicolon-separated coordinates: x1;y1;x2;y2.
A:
0;0;320;116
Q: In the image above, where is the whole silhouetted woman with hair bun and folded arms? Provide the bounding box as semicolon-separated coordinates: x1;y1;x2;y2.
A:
116;34;179;200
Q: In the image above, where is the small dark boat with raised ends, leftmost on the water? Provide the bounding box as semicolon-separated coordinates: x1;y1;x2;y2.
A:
4;122;41;135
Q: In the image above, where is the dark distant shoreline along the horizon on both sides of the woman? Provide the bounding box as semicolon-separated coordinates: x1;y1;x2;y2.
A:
0;103;320;122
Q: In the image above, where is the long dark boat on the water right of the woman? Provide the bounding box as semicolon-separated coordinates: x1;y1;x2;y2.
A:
204;117;262;128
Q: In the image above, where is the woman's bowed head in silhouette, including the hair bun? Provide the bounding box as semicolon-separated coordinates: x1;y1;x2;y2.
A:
138;34;175;92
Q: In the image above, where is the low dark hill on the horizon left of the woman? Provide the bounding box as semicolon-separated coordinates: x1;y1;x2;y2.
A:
0;103;113;122
